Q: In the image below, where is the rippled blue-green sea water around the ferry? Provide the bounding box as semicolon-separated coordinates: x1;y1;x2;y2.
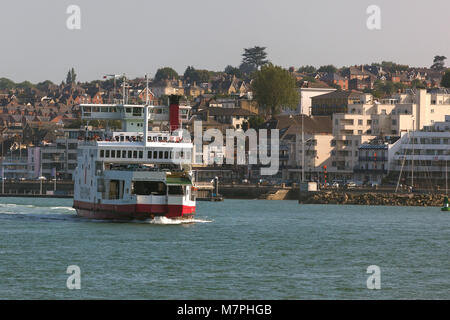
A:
0;198;450;299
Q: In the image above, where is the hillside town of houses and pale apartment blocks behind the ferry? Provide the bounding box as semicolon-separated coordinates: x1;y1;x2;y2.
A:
0;47;450;192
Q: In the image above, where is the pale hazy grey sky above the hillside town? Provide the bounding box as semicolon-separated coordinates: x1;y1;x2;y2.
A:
0;0;450;83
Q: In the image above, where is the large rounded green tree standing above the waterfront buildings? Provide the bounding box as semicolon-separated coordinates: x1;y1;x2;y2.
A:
252;63;299;118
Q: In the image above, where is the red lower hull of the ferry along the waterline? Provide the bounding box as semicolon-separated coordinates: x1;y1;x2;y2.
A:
73;201;195;221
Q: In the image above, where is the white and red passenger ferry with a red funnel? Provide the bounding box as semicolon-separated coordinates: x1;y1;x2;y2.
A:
73;96;196;220
